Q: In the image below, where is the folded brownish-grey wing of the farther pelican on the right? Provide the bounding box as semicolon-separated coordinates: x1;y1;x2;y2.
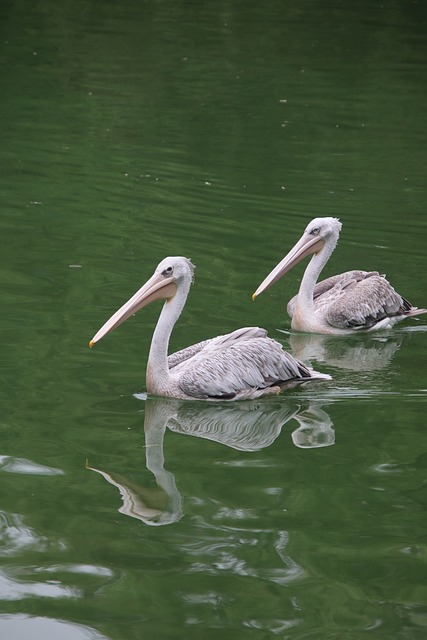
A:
324;272;411;329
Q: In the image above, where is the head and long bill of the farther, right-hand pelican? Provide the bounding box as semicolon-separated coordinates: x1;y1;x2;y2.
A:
252;218;341;300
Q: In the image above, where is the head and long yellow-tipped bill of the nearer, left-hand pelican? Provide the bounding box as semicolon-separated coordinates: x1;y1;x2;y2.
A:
89;256;194;347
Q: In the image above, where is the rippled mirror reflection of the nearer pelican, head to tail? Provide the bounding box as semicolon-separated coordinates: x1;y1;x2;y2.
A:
87;398;335;526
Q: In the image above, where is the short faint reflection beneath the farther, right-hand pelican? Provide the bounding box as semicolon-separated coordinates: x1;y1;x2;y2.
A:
289;333;405;371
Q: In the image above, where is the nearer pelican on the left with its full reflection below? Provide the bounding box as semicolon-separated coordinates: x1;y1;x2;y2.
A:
89;257;330;400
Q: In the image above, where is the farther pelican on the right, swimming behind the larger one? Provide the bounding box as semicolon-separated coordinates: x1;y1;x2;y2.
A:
252;218;427;334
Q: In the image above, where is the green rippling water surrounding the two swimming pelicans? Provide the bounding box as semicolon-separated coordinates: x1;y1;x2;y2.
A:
0;0;427;640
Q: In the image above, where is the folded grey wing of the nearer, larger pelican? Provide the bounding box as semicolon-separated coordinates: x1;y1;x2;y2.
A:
172;327;313;399
